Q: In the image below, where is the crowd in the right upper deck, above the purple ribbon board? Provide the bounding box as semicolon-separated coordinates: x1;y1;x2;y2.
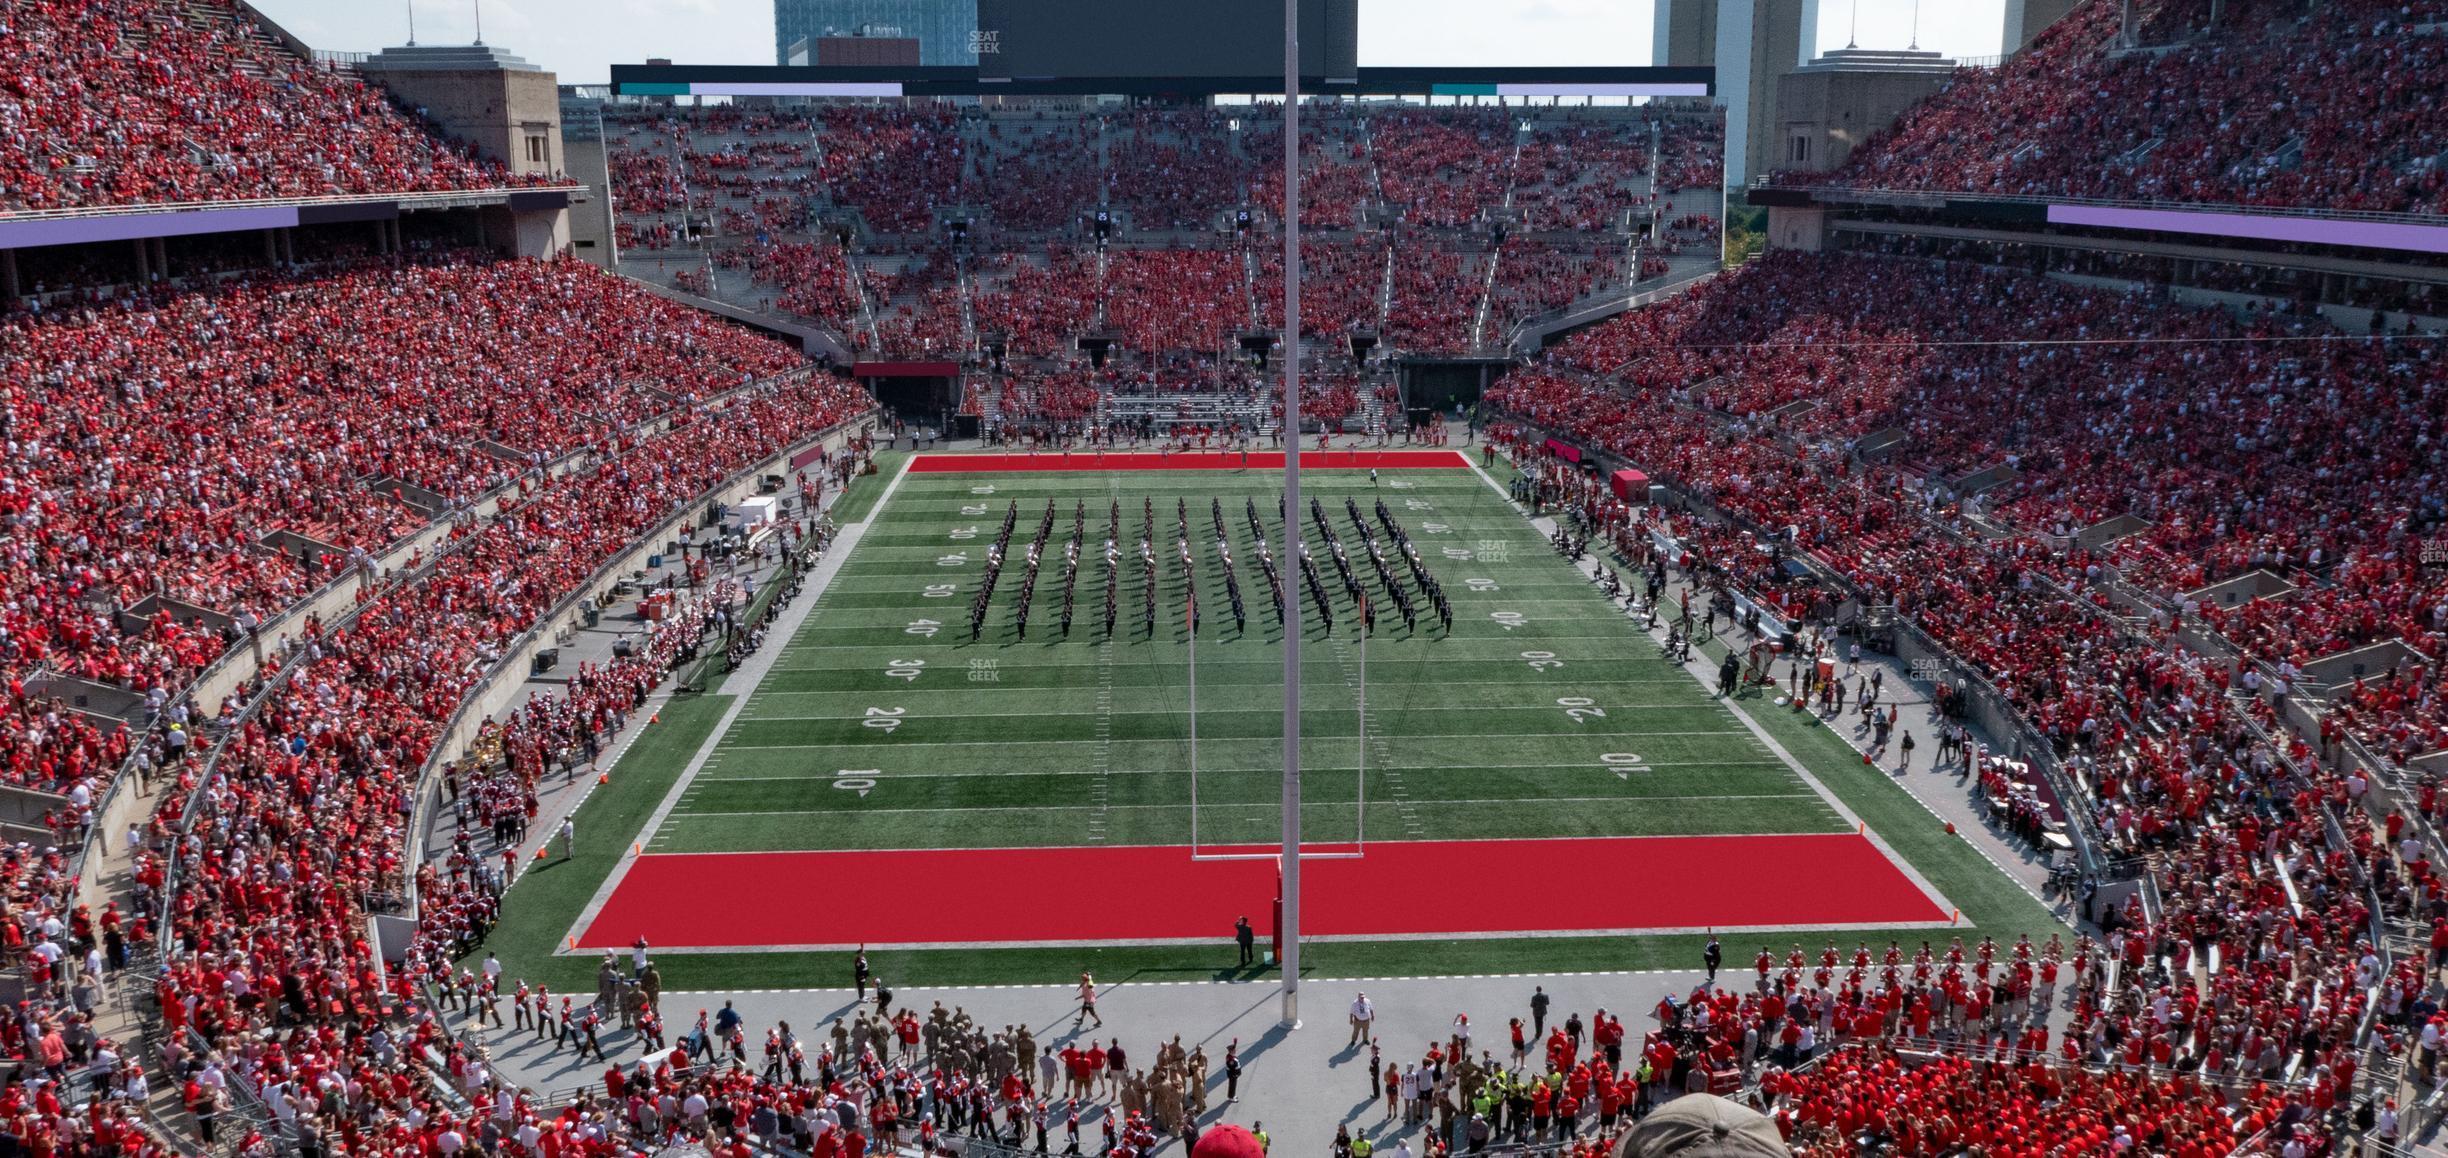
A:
1777;0;2448;215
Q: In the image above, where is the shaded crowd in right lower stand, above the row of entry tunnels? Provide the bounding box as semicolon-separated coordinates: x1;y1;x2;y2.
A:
1559;244;2448;714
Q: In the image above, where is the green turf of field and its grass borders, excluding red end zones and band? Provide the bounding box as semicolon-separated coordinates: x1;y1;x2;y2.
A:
494;463;2051;989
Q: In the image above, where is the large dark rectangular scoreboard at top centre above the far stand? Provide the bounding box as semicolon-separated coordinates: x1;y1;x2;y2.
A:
972;0;1359;88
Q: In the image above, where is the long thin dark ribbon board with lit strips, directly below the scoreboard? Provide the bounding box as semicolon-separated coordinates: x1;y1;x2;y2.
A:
612;64;1716;98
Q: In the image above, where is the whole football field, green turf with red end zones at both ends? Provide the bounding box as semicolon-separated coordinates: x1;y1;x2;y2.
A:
573;453;1949;952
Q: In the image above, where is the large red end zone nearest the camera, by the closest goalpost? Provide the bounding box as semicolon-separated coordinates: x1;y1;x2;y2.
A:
575;832;1946;950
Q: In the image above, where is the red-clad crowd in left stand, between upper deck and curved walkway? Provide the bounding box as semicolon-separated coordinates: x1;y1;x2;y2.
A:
0;255;791;807
